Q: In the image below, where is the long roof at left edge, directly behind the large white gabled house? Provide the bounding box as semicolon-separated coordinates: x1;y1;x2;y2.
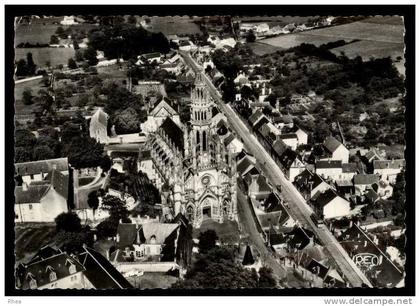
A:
15;157;69;176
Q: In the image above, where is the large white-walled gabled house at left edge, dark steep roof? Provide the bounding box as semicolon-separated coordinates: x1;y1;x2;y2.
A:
15;169;69;222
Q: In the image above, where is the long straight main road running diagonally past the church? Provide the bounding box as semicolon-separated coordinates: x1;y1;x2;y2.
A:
180;52;372;287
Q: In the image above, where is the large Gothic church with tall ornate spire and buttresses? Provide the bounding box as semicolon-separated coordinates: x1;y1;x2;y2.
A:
139;74;237;228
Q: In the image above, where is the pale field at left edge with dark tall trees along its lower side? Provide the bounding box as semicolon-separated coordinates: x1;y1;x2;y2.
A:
15;48;75;68
